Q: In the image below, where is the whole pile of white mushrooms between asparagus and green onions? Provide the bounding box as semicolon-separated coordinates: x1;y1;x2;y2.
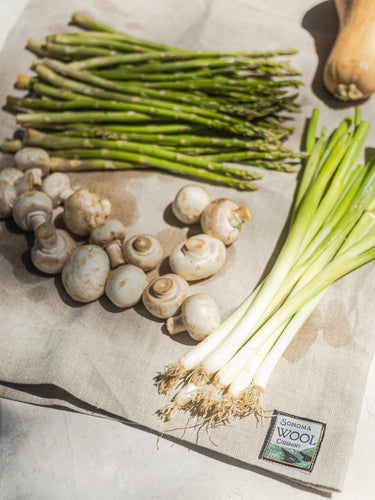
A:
0;148;251;341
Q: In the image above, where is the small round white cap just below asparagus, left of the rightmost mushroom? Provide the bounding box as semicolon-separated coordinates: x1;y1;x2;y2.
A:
172;184;211;224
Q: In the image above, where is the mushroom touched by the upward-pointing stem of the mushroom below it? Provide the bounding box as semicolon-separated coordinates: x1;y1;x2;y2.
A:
13;191;53;231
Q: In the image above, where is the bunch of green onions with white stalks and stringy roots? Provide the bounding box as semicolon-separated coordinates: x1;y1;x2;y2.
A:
157;109;375;425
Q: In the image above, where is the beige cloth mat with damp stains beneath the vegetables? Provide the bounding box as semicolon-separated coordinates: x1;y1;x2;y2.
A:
0;0;375;490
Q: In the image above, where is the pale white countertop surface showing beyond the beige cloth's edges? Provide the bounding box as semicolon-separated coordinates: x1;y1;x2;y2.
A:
0;0;375;500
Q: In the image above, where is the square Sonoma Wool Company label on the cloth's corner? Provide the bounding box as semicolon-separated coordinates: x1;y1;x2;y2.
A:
259;410;326;472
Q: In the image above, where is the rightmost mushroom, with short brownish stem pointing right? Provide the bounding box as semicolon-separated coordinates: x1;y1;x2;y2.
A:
200;198;252;245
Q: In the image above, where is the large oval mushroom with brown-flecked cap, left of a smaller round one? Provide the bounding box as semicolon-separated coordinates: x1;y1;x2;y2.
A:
61;245;110;302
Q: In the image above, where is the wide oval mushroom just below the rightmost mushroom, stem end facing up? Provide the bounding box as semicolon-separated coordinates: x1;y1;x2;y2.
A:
169;234;226;281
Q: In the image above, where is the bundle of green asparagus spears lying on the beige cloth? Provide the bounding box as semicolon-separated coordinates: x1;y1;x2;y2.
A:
2;13;301;190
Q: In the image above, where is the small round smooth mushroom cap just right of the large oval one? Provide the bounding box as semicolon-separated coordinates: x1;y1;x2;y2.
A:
105;264;147;307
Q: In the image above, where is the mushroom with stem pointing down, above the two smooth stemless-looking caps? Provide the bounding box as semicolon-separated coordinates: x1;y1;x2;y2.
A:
89;219;126;268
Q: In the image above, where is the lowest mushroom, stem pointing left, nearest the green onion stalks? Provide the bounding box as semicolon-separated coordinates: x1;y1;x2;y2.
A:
166;293;220;341
